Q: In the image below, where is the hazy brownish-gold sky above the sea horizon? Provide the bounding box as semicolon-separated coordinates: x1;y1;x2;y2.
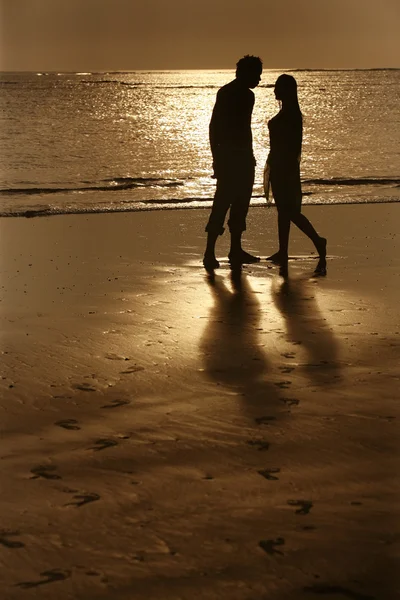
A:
0;0;400;72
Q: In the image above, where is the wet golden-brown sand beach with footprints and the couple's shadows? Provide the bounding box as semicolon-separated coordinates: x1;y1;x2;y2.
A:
0;204;400;600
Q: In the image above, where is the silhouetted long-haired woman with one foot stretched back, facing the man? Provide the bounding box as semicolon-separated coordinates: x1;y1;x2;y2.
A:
267;74;326;274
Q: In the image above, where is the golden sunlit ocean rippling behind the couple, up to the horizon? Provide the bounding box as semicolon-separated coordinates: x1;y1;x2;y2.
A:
0;69;400;216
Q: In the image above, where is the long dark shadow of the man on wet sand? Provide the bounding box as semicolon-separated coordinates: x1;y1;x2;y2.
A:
200;271;282;417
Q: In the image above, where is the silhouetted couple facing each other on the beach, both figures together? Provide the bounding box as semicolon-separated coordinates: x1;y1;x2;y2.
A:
203;56;326;274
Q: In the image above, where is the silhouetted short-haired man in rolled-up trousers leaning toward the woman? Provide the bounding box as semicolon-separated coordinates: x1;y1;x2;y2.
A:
203;55;262;271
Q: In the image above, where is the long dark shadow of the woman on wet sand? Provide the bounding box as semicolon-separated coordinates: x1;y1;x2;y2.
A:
271;277;341;385
